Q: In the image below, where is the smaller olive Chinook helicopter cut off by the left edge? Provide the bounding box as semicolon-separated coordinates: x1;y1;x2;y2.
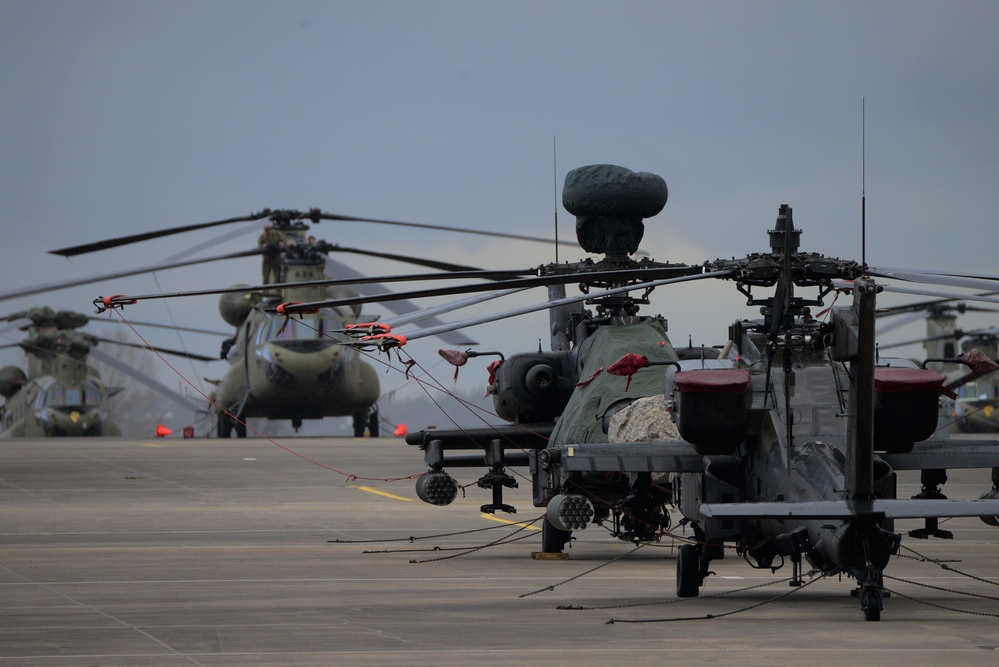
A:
0;307;213;438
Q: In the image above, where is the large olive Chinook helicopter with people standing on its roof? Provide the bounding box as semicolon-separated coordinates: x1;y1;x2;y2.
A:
50;209;572;437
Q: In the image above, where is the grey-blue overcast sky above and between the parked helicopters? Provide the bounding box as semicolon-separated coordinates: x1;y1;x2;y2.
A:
0;0;999;420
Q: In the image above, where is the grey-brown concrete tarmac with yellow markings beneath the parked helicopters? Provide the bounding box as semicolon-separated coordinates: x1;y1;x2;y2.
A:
0;437;999;667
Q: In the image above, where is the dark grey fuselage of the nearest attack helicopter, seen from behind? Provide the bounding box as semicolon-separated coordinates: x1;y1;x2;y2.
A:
676;326;916;578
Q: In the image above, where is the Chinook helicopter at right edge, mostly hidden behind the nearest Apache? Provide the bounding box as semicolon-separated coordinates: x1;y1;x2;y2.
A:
878;301;999;433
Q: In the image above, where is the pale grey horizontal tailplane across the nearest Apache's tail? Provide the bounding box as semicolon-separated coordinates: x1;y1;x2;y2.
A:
700;499;999;520
